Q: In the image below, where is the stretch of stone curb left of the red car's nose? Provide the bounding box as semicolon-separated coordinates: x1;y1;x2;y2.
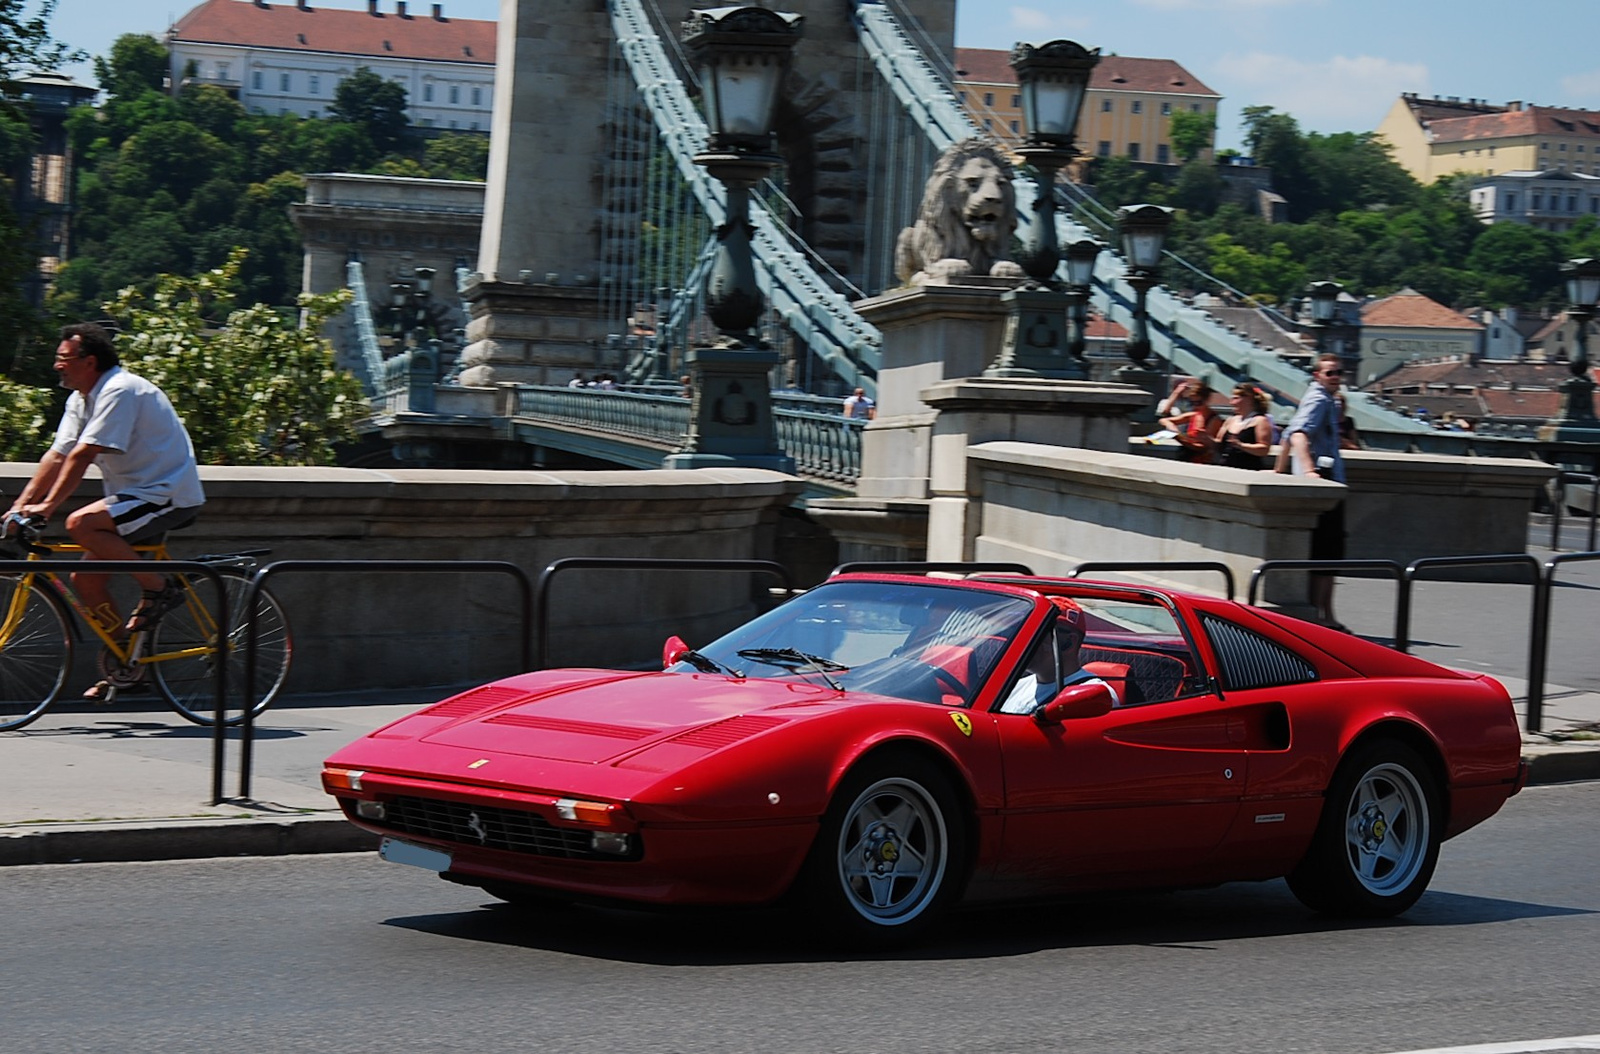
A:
0;817;378;867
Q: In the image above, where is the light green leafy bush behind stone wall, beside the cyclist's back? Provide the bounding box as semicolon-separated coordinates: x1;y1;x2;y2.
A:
107;251;368;465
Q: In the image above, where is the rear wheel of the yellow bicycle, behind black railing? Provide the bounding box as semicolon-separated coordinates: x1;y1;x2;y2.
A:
150;573;291;725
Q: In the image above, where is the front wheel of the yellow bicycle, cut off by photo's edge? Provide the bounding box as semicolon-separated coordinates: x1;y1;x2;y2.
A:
0;576;72;731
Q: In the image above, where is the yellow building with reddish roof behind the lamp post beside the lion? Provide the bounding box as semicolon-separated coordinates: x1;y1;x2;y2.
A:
955;48;1222;165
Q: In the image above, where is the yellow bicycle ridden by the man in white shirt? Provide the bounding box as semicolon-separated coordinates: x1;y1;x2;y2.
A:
0;517;293;731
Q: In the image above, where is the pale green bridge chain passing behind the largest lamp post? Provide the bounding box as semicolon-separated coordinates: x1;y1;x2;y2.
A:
610;0;882;392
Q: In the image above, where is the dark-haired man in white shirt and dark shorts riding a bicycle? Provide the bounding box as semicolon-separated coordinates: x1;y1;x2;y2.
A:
6;323;205;665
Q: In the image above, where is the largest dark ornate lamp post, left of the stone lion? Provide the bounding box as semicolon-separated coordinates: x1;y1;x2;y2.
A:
666;6;803;472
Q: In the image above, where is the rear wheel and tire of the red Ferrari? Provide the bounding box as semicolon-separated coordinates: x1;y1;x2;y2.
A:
1288;741;1442;918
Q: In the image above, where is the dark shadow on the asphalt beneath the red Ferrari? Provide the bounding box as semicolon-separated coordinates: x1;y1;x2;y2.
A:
384;881;1592;966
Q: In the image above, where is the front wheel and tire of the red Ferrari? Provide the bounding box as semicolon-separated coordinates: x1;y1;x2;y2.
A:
802;755;966;947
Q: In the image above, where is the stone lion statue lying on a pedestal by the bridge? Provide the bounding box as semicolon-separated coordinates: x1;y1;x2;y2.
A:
894;138;1022;285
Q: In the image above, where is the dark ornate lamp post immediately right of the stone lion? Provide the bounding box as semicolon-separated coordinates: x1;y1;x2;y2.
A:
984;40;1099;381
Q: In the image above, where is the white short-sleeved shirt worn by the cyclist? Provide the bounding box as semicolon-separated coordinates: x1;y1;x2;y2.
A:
51;366;205;509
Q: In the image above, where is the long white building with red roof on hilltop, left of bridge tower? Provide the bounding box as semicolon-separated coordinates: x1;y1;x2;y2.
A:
166;0;496;134
